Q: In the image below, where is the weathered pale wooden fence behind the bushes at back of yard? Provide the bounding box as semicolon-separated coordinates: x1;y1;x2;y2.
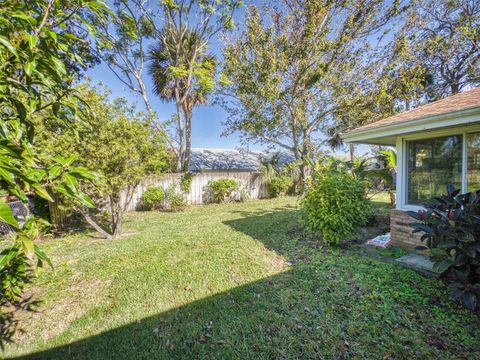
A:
122;171;267;211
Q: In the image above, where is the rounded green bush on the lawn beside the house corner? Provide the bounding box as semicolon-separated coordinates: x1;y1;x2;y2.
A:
301;171;372;245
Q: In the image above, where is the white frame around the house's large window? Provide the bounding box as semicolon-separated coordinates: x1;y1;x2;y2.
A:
396;122;480;211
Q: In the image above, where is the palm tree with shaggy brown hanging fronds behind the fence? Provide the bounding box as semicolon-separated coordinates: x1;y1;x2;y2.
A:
149;26;216;171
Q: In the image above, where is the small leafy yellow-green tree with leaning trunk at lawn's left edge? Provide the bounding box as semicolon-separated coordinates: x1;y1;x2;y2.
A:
36;84;170;238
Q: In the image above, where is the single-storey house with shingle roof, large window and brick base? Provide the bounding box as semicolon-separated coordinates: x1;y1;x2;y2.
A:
343;88;480;248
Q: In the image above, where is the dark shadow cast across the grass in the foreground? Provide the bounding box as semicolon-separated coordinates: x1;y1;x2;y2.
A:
15;208;480;359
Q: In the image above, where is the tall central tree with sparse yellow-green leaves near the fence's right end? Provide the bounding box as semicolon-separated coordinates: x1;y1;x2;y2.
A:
223;0;402;177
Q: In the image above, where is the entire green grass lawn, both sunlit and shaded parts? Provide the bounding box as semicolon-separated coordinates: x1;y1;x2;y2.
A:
4;198;480;359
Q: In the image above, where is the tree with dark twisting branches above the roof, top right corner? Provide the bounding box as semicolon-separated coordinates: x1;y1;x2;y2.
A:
396;0;480;101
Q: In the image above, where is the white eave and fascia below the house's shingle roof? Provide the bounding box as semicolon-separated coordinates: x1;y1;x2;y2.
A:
341;106;480;144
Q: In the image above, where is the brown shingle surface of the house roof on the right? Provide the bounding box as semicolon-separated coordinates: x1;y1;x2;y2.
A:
350;88;480;133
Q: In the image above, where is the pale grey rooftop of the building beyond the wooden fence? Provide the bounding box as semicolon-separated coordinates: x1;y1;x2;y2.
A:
189;148;293;172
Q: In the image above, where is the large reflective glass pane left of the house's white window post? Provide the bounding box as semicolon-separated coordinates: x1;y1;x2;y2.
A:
407;135;462;204
